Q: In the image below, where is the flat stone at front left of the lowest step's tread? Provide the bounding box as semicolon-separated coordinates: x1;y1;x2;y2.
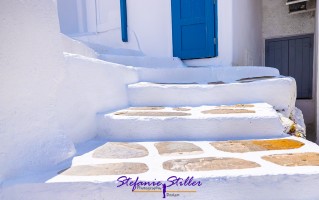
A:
59;162;148;176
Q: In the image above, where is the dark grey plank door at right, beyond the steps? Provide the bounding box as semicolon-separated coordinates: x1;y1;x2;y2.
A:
265;34;313;99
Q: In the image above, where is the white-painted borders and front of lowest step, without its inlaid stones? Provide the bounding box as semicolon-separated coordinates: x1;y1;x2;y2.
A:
0;137;319;200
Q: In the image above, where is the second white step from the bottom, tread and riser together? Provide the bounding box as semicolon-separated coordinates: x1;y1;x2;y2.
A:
98;103;283;141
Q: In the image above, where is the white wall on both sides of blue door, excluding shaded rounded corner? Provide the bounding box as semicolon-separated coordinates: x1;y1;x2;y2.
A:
67;0;238;66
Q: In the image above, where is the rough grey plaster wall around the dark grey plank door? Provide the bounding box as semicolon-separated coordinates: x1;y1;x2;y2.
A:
262;0;317;140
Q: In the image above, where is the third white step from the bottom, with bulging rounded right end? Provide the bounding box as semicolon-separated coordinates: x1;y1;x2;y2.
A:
128;77;296;116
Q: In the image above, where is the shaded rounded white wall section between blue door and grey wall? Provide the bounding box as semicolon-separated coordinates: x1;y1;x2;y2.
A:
233;0;262;66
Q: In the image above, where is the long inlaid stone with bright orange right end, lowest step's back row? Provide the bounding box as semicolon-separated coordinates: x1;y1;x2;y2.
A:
210;139;304;153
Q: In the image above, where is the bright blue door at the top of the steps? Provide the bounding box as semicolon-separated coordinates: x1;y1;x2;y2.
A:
171;0;217;59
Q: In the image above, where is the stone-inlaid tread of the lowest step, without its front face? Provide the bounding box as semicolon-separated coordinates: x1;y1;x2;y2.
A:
51;137;319;178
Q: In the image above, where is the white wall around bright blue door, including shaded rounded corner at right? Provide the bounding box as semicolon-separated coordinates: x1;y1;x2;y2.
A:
61;0;251;66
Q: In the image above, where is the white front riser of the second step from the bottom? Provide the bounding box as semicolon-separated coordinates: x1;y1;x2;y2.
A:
99;116;283;141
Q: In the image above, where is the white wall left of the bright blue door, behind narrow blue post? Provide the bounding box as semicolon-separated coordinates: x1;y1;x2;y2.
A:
76;0;172;57
